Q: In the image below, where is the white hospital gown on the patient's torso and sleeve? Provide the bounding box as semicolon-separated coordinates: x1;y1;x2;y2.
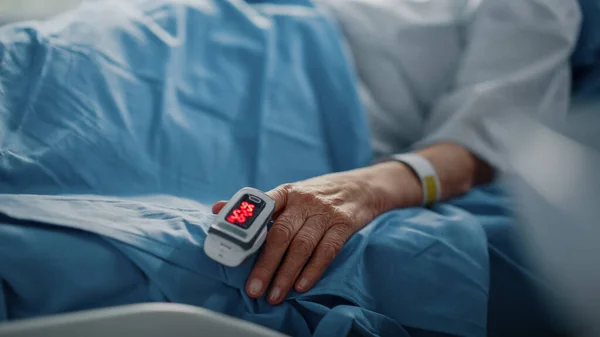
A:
320;0;580;168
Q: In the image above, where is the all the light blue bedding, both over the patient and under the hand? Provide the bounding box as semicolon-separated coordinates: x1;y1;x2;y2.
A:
0;0;492;336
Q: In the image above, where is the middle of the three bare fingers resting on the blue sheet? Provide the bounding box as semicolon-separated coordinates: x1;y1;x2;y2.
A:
267;215;327;304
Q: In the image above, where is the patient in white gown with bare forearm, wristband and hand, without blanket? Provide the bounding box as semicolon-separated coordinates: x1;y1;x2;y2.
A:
213;0;579;304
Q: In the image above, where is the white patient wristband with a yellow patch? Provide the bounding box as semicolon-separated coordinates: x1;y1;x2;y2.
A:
390;153;442;205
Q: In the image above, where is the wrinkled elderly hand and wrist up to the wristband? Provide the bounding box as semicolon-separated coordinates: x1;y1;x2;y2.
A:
213;162;422;304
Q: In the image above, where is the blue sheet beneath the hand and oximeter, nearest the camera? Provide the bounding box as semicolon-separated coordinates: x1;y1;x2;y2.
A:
0;190;494;336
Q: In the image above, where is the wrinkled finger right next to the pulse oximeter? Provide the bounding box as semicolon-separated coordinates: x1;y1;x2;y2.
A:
246;207;304;298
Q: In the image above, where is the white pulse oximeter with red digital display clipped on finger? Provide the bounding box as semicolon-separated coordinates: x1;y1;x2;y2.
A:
204;187;275;267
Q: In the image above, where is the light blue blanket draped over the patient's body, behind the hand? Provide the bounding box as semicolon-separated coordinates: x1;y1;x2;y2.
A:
0;0;371;201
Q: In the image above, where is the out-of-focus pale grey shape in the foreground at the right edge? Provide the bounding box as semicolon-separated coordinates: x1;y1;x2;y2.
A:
505;100;600;336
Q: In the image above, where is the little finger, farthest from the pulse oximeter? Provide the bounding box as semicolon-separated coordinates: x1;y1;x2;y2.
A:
295;225;352;292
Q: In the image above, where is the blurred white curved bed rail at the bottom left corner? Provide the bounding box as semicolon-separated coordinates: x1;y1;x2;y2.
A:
0;303;284;337
